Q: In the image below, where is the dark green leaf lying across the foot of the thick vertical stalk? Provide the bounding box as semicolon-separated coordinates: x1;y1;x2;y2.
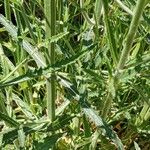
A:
0;115;75;146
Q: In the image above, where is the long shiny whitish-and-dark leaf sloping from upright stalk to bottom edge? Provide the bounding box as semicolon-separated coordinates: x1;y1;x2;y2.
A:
56;77;124;150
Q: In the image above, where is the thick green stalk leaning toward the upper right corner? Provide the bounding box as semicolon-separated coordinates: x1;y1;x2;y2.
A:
102;0;147;118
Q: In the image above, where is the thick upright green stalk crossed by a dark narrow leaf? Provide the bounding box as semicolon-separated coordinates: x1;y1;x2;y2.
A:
44;0;56;122
